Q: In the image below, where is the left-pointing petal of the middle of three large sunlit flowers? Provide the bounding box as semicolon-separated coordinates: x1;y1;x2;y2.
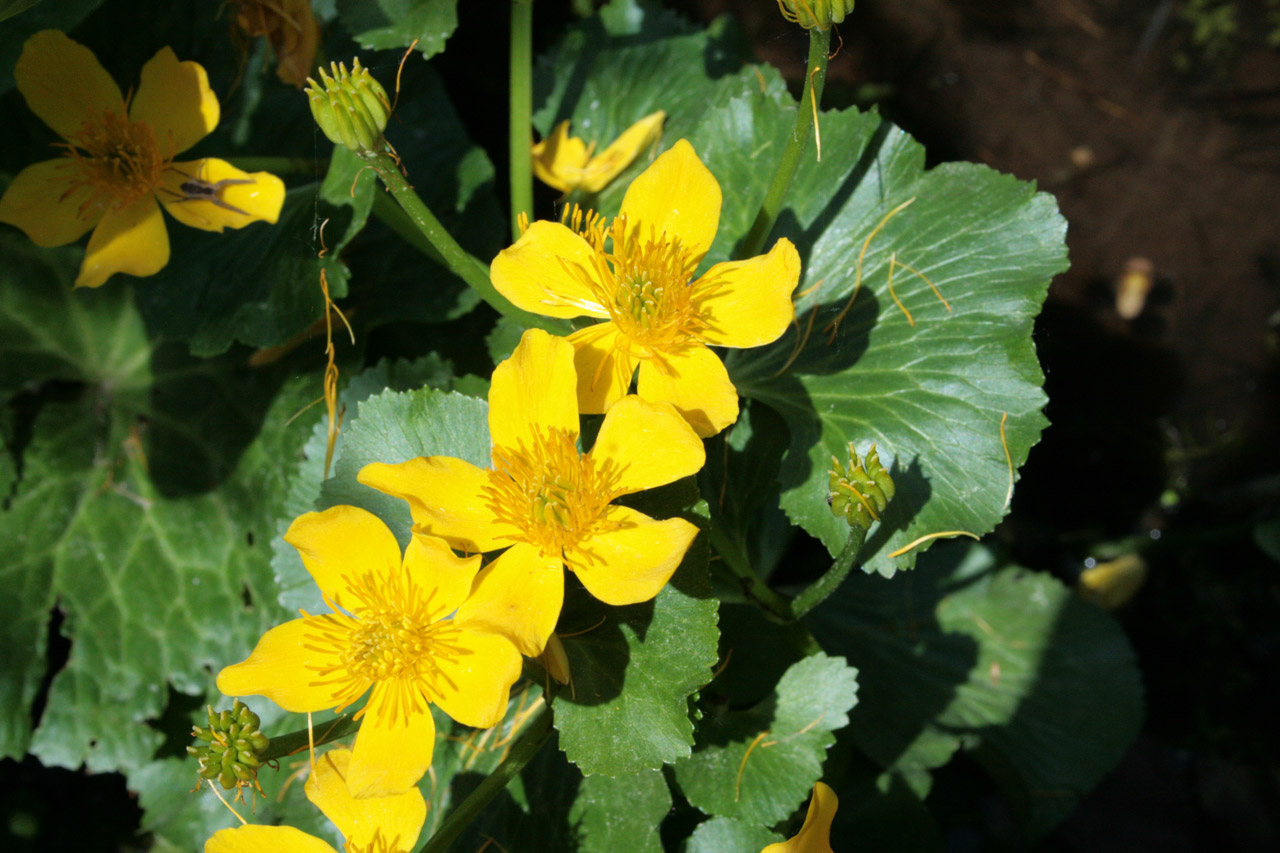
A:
356;456;509;553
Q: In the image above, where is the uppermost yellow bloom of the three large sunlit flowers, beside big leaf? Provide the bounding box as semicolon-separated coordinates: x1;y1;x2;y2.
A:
490;140;800;435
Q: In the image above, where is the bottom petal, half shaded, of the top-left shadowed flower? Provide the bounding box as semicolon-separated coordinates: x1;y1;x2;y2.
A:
76;196;169;287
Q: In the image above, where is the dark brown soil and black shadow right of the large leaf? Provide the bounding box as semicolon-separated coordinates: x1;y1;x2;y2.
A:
676;0;1280;850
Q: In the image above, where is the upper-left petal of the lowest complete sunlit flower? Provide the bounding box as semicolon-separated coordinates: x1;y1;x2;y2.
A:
284;506;401;611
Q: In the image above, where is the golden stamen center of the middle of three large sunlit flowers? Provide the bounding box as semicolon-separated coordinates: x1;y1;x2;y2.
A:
485;429;618;556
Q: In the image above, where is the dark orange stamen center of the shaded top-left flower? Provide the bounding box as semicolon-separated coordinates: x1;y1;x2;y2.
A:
60;110;173;218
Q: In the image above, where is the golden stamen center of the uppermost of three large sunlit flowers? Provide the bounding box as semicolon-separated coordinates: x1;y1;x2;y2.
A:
571;214;707;359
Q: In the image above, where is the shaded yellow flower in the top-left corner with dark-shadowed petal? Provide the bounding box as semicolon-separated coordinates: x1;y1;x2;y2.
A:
0;29;284;287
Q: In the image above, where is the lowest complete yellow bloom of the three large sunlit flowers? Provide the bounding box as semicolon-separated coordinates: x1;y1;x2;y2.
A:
218;506;521;797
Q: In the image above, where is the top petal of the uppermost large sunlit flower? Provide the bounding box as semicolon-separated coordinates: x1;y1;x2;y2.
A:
620;140;721;257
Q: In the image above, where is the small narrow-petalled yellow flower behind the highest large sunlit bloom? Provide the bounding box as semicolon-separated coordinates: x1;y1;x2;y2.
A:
534;110;667;192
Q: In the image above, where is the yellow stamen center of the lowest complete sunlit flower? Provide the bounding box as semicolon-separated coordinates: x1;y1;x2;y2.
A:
306;566;463;725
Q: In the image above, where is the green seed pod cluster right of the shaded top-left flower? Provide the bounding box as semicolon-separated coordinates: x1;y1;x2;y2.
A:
303;59;392;154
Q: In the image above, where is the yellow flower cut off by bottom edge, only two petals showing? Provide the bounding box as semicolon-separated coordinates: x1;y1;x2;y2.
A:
205;749;426;853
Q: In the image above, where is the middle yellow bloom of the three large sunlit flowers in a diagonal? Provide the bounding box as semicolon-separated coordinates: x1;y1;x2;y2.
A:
358;329;705;657
